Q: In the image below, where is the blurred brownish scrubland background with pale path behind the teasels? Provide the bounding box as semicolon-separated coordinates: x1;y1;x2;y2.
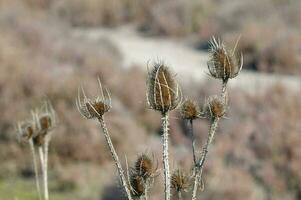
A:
0;0;301;200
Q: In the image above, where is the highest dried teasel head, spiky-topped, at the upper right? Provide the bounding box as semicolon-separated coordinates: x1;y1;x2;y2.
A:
207;37;243;81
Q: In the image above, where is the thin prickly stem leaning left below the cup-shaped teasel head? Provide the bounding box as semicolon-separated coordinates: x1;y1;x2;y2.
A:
98;116;132;200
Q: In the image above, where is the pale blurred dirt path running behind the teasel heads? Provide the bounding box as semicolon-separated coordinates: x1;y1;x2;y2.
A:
73;28;301;93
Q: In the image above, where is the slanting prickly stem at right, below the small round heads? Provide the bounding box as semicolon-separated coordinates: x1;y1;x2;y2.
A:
192;118;220;200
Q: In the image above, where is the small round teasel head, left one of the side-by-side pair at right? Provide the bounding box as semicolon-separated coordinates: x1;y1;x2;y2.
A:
181;99;200;120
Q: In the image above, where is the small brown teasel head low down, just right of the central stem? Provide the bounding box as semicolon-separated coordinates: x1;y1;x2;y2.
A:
171;169;190;192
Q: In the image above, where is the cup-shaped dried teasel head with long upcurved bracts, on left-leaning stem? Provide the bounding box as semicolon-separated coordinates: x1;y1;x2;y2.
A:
76;78;112;119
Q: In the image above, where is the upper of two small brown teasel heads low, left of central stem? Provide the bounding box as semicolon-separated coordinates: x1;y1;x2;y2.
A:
135;154;155;179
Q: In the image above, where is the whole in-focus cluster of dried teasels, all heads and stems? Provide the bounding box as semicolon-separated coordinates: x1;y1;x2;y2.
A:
72;37;243;200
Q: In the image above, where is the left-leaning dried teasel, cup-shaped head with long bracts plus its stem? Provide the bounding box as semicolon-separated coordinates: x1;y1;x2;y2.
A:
76;78;132;200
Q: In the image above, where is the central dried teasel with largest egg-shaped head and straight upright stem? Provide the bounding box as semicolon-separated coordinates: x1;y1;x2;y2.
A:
146;62;182;200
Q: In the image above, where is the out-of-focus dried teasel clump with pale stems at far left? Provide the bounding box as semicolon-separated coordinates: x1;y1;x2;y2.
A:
17;101;57;200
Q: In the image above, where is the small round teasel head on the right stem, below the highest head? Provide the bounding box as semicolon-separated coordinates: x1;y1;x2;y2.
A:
204;95;226;118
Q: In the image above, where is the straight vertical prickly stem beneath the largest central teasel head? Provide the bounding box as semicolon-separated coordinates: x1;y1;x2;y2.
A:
162;112;170;200
